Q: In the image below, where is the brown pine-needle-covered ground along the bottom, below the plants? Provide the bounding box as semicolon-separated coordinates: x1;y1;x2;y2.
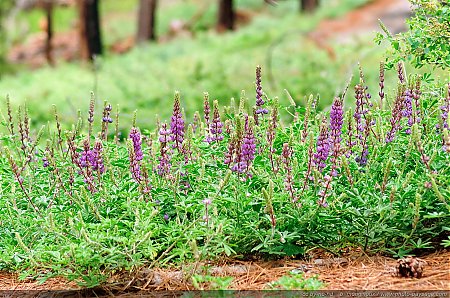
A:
0;250;450;290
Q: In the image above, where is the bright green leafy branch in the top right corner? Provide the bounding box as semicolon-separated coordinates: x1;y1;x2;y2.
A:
375;0;450;69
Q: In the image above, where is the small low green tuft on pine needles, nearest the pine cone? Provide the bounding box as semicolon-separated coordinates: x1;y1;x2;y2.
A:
267;272;324;291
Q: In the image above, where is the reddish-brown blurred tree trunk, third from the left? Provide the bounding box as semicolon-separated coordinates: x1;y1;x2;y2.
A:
136;0;158;42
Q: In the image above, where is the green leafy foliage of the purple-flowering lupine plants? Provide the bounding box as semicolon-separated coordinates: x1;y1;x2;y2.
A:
0;67;450;288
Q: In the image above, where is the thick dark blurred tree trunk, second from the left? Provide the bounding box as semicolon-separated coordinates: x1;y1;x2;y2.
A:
77;0;103;60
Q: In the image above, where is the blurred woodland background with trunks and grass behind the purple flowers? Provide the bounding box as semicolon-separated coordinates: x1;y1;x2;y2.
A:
0;0;410;129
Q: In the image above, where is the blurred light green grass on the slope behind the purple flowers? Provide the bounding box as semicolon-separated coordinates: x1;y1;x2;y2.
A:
0;1;394;134
